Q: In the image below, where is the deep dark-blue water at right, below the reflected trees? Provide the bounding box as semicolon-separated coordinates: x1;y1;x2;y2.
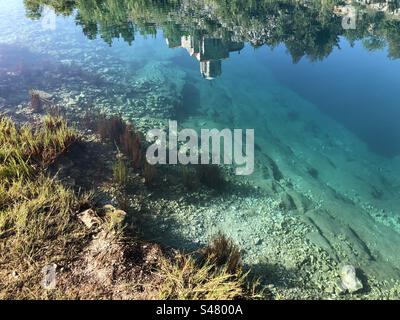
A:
262;39;400;155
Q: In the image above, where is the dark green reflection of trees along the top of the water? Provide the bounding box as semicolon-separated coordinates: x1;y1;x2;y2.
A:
25;0;400;62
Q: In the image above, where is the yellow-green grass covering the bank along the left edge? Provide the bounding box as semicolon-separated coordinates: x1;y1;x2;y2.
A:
0;116;88;299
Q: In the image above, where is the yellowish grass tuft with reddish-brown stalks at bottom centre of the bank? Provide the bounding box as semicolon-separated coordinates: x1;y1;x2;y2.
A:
158;234;263;300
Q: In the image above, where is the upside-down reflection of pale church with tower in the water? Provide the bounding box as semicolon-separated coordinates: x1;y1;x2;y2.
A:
167;36;244;80
